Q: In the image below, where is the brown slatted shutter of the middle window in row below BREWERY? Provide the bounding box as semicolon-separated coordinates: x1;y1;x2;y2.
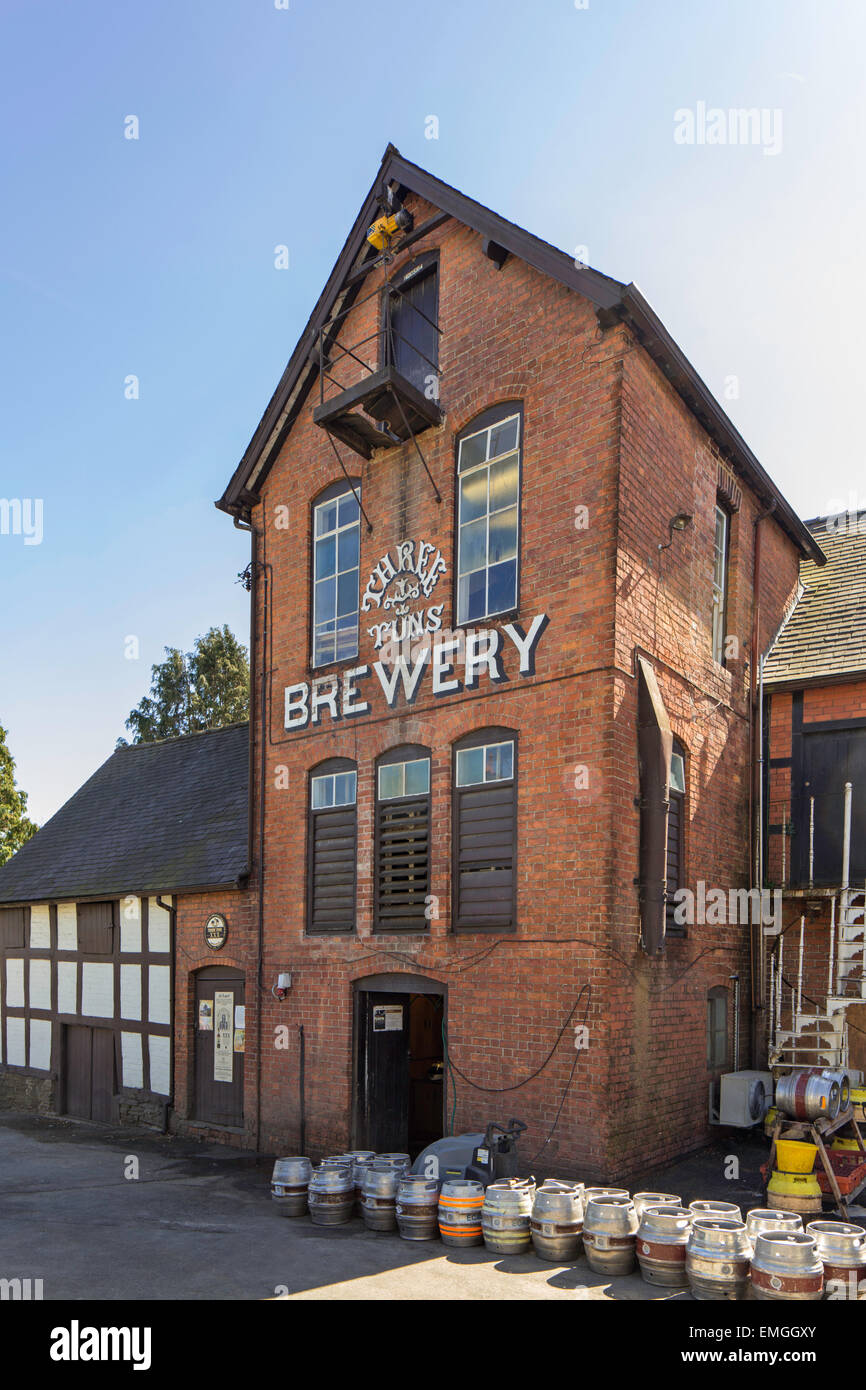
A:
375;795;430;931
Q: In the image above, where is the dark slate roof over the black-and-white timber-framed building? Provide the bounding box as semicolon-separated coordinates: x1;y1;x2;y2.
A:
0;723;249;902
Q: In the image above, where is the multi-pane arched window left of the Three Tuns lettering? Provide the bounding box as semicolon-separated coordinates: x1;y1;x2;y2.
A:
311;480;361;666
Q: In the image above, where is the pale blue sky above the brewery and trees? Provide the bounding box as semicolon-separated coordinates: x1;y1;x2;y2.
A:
0;0;866;821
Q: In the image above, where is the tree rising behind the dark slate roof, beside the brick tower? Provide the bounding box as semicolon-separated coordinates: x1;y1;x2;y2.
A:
117;624;250;748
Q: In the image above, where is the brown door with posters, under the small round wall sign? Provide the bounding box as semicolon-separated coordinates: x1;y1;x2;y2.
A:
193;965;246;1129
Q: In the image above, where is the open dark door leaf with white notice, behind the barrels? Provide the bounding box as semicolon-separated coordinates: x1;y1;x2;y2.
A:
357;990;410;1154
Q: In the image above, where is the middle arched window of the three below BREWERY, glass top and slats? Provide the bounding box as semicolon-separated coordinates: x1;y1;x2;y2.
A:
374;744;430;931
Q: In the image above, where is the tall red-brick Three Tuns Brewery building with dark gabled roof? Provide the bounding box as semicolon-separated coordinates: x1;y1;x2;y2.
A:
0;147;823;1179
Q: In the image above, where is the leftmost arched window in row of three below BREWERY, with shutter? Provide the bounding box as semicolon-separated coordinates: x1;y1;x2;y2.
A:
307;758;357;933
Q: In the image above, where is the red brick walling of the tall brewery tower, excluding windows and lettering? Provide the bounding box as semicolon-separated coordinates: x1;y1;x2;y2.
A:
202;193;796;1177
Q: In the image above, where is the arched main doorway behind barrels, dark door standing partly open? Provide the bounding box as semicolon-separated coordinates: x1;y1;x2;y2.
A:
354;976;445;1159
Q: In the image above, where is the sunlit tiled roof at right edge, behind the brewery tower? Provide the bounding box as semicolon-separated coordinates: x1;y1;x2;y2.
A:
763;512;866;688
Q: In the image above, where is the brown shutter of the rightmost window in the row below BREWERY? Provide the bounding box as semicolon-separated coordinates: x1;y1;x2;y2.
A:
453;780;516;931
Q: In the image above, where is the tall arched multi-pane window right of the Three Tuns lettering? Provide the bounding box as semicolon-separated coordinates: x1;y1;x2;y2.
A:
457;402;523;623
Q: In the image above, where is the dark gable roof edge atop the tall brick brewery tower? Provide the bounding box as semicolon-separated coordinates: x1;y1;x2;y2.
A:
215;145;824;564
